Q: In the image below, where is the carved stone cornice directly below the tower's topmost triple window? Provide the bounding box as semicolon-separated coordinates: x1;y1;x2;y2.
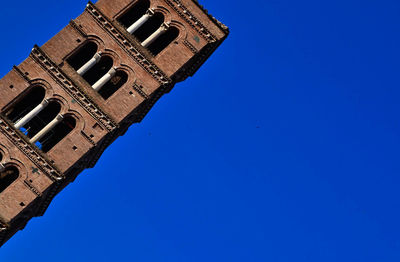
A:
86;2;172;85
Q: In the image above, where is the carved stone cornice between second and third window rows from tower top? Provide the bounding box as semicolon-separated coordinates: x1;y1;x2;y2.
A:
30;46;118;132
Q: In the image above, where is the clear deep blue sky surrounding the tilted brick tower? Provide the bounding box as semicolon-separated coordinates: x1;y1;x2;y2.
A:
0;0;400;262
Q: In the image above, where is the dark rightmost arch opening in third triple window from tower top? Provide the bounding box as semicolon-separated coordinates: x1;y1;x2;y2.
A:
39;116;76;153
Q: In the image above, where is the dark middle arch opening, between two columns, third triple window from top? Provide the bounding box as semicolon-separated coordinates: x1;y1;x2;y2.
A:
21;101;61;138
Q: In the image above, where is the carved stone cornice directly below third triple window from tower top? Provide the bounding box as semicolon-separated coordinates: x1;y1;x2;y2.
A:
0;114;64;181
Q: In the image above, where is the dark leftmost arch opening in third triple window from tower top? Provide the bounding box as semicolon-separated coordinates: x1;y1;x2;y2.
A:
6;86;46;123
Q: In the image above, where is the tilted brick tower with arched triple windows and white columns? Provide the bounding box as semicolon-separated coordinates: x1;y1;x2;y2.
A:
0;0;229;245
